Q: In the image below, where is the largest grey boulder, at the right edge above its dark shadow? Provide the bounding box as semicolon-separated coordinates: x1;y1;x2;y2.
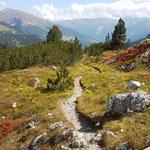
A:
107;93;150;116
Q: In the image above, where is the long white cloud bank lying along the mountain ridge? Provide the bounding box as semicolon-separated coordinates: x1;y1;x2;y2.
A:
33;0;150;20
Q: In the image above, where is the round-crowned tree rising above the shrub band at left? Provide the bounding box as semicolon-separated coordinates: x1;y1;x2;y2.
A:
47;26;62;43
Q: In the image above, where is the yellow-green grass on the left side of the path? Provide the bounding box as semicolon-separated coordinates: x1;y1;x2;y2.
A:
0;67;72;150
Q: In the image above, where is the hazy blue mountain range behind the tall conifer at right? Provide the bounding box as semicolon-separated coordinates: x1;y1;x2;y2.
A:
57;17;150;41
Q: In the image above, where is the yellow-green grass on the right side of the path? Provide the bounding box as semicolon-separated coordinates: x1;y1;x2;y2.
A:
72;55;150;150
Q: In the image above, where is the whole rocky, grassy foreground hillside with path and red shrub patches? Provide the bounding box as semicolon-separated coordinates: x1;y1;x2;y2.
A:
0;41;150;150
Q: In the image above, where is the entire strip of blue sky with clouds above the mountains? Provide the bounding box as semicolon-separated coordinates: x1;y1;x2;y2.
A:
0;0;150;21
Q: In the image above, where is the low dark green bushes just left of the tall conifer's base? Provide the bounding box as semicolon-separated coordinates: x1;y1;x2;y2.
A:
84;43;103;56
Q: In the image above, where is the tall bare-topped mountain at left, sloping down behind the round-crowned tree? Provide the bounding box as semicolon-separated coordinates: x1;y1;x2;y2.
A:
0;9;94;45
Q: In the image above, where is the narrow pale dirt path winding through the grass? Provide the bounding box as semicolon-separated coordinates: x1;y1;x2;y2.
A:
62;77;101;150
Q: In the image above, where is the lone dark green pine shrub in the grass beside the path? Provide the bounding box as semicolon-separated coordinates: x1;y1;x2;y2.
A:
47;66;73;91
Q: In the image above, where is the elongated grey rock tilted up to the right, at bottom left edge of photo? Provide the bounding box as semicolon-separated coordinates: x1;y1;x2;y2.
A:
29;132;47;150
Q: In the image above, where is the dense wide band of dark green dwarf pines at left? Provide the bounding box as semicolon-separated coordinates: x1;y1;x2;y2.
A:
0;38;82;71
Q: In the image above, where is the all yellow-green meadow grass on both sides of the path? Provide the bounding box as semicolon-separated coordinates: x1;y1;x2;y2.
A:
0;52;150;150
